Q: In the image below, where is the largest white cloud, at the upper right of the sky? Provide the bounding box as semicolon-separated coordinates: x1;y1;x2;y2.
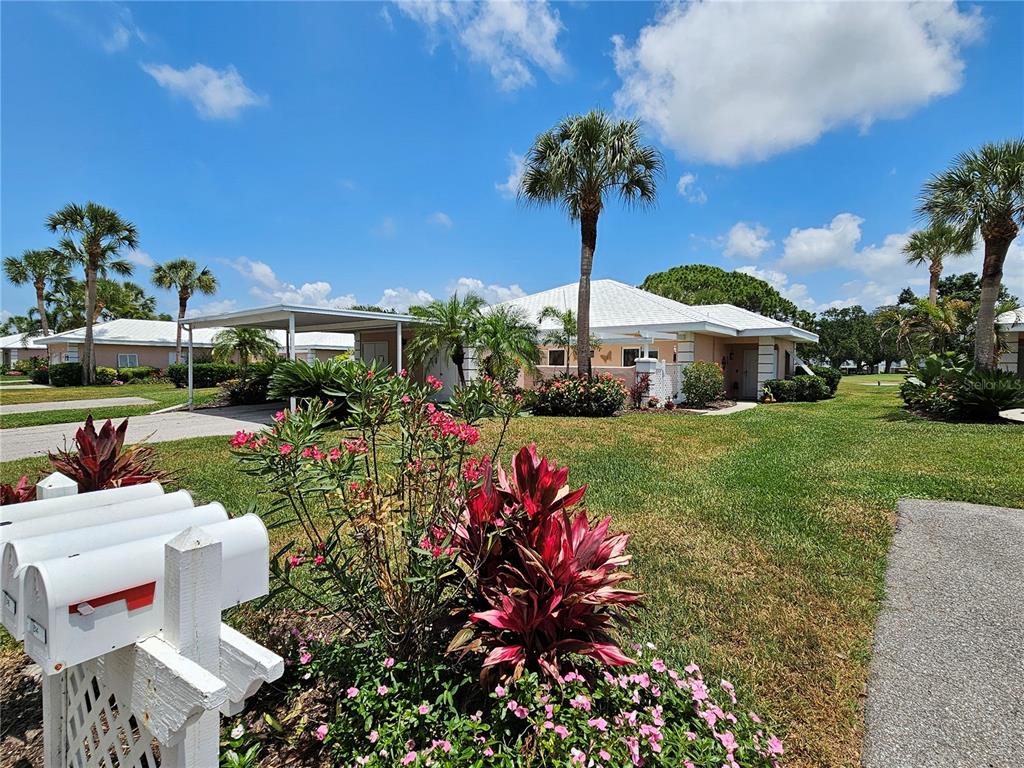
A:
612;0;983;165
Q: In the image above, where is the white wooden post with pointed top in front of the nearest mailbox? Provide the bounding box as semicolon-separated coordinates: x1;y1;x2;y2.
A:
161;527;222;768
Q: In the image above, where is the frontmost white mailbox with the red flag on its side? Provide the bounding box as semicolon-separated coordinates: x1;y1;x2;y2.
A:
23;514;269;675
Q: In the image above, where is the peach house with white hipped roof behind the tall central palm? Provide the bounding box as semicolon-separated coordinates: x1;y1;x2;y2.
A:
491;280;818;399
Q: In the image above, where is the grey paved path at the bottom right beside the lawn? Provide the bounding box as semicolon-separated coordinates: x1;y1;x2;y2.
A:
862;499;1024;768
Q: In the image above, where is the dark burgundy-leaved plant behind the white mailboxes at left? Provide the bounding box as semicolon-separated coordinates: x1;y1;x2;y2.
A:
49;416;167;494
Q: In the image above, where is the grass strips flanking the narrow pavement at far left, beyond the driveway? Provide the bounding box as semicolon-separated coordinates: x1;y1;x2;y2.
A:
0;382;218;429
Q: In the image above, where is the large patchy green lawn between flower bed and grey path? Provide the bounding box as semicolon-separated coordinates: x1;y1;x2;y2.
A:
0;376;1024;768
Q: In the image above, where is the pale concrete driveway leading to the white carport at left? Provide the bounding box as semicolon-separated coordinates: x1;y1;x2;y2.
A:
0;403;281;462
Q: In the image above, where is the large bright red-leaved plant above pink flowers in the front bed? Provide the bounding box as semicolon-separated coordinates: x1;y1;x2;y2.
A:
450;445;641;678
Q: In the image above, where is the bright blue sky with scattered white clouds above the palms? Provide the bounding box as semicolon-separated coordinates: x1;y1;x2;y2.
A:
0;2;1024;315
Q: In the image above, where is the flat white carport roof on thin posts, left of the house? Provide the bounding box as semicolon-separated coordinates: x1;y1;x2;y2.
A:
181;304;423;333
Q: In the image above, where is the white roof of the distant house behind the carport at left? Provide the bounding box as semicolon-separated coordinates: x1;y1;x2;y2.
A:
40;318;355;350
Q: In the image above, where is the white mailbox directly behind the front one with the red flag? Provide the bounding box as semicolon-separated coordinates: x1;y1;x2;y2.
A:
0;505;227;640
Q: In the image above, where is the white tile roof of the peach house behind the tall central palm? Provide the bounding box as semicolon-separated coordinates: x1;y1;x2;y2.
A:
491;280;817;341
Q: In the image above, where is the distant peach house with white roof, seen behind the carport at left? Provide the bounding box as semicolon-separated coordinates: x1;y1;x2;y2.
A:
46;319;353;369
